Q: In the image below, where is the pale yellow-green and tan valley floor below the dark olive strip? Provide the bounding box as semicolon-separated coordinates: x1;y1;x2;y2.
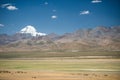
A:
0;58;120;80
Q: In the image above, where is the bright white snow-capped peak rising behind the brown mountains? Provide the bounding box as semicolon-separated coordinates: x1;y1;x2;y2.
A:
19;25;46;36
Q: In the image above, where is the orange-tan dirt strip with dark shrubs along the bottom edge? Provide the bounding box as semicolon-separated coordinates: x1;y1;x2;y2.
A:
0;70;120;80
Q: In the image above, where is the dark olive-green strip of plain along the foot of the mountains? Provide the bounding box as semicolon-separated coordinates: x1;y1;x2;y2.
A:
0;50;120;59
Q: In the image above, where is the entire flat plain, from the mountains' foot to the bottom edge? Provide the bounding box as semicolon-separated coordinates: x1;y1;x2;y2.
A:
0;51;120;80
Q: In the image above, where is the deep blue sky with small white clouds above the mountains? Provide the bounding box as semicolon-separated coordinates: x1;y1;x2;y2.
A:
0;0;120;34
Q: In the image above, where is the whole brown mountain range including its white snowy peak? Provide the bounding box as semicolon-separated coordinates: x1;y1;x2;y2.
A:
0;25;120;52
